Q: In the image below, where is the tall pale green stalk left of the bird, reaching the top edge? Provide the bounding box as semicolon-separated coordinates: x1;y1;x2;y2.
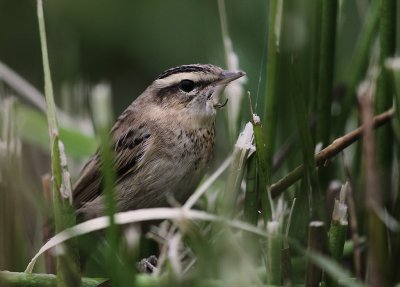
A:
37;0;81;286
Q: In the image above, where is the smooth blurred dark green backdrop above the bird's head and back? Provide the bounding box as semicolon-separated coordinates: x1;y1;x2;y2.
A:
0;0;266;111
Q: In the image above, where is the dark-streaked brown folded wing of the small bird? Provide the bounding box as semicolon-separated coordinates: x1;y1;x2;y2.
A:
73;113;151;208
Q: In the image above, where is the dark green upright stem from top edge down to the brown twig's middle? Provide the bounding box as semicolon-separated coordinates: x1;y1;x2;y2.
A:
316;0;339;147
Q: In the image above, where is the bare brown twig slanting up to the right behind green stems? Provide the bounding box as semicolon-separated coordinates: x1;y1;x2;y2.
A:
271;109;394;198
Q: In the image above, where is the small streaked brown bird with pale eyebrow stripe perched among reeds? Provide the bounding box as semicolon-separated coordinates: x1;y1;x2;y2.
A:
73;64;245;219
